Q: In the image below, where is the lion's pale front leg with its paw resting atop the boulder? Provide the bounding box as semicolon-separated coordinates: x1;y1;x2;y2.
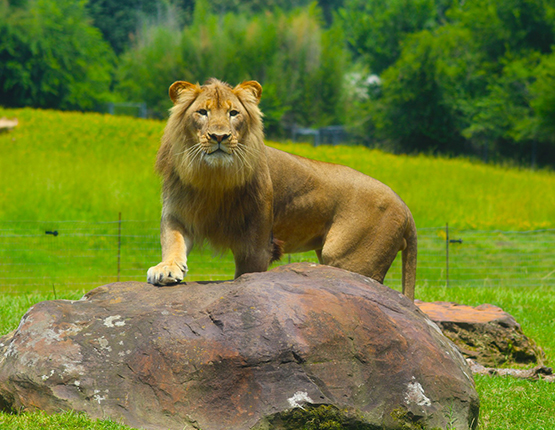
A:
147;216;193;285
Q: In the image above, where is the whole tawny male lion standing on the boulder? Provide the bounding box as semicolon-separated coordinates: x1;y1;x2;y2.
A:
147;79;417;299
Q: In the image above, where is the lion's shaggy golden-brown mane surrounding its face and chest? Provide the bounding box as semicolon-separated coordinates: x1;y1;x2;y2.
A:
156;79;267;251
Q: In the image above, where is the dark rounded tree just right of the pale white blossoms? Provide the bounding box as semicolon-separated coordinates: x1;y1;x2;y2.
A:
374;28;473;154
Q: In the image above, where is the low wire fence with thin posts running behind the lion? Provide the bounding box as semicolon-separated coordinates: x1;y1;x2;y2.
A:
0;220;555;293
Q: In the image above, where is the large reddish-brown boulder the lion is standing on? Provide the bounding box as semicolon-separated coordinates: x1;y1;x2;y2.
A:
0;263;478;430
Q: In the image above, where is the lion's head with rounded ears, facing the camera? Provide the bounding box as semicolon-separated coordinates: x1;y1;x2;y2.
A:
156;79;264;189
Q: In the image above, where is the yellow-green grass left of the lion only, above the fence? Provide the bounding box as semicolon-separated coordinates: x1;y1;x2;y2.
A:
0;108;163;221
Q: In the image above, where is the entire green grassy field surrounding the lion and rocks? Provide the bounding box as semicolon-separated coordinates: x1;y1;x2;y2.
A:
0;108;555;430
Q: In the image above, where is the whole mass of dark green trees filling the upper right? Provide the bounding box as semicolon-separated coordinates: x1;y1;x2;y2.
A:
350;0;555;163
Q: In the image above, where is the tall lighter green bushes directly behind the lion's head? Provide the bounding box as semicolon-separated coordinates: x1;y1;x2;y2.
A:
118;1;348;132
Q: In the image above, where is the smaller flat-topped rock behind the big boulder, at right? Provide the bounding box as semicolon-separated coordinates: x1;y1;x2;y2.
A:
416;301;544;367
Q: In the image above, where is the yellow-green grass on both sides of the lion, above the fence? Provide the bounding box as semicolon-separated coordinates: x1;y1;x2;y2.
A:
0;108;555;230
